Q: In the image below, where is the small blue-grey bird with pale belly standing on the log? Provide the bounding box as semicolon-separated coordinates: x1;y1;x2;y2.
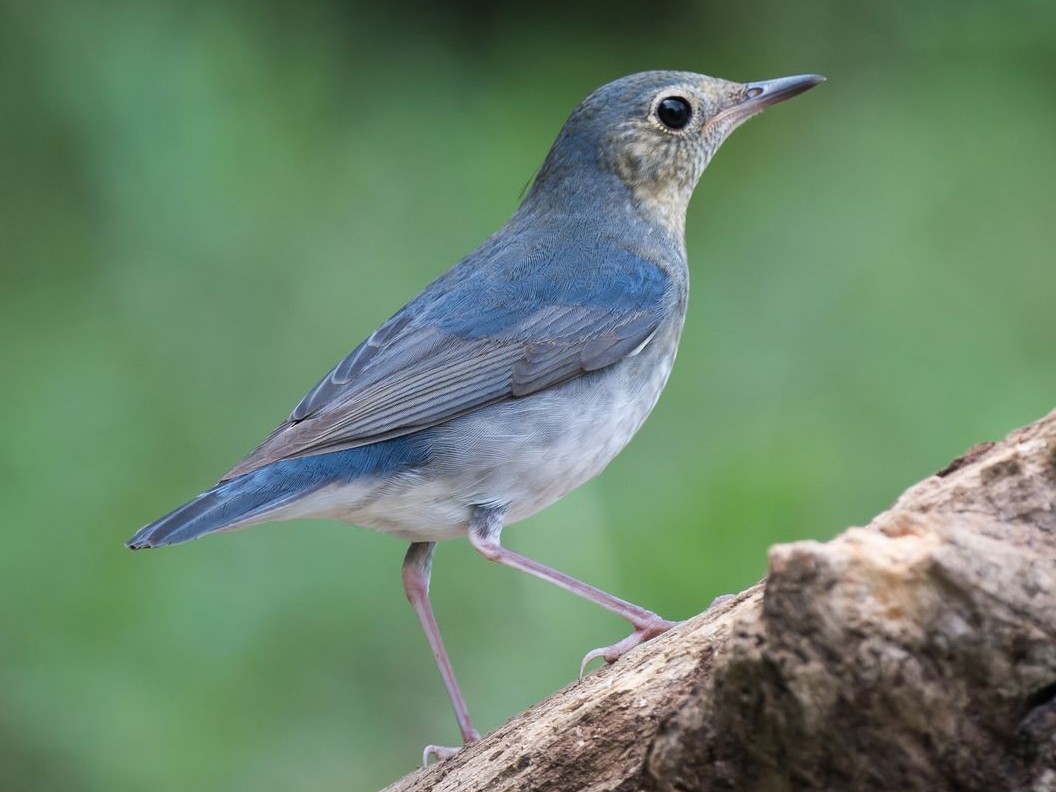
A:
127;71;824;761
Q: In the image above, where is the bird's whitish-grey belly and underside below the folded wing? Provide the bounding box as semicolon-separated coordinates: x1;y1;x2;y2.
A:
287;331;674;542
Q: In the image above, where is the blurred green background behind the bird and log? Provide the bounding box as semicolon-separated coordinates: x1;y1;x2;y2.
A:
0;0;1056;791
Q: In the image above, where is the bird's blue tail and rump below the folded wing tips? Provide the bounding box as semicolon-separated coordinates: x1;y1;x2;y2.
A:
126;435;427;550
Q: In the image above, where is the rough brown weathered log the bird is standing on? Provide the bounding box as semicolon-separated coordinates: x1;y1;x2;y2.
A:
388;412;1056;792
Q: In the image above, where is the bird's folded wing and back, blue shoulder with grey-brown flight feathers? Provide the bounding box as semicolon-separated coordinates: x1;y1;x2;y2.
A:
224;238;674;479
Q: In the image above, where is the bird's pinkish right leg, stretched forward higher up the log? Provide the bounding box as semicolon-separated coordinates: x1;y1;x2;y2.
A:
469;506;675;676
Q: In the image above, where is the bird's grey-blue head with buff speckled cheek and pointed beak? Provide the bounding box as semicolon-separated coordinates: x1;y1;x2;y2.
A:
529;72;824;234
